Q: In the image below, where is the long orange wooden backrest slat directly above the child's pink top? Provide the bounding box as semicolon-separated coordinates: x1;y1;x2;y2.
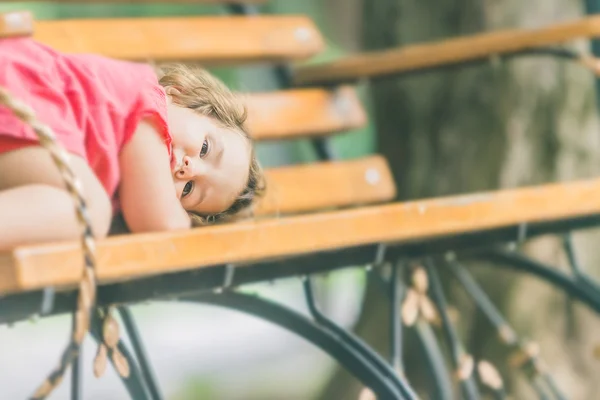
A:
34;16;323;65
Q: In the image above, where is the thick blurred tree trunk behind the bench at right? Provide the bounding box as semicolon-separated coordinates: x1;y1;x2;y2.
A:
322;0;600;399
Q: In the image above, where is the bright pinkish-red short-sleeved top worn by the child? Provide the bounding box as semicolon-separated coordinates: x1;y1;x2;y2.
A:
0;38;171;209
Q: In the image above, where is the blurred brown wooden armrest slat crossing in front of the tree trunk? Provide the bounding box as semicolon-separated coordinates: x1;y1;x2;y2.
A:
294;16;600;85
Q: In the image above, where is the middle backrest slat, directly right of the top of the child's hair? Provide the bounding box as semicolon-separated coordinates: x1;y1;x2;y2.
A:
246;87;367;140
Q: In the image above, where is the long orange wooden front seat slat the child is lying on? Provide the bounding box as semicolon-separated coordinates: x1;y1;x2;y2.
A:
0;179;600;293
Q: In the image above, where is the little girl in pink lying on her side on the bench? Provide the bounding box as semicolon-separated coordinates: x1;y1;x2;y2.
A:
0;38;264;251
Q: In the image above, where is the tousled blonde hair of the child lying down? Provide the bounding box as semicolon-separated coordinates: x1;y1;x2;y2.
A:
155;64;265;225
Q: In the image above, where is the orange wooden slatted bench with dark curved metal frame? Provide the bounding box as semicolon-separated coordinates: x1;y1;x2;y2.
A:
0;0;600;399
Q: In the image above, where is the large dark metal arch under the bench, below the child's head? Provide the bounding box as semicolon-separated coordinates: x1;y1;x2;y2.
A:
179;292;416;399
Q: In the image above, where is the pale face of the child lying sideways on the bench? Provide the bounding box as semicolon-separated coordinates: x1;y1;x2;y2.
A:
169;105;251;214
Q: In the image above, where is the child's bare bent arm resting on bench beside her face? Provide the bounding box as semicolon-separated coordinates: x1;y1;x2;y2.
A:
119;122;191;232
